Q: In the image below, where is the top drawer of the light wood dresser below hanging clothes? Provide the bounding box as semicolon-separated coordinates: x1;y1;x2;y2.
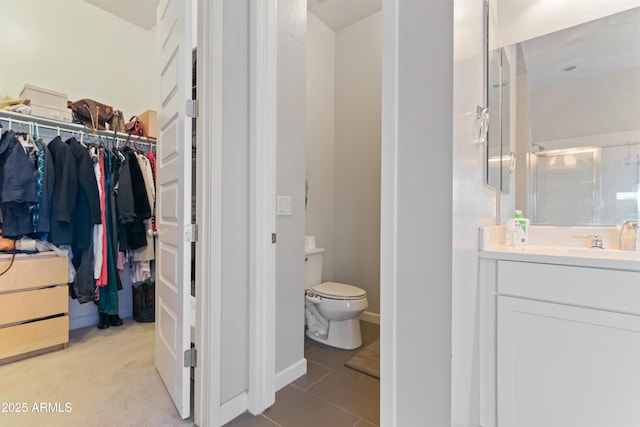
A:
0;252;69;293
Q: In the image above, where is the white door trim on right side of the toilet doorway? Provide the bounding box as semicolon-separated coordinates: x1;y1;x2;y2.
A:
380;0;400;426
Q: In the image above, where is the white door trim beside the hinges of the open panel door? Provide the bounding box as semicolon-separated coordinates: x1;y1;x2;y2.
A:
194;1;224;426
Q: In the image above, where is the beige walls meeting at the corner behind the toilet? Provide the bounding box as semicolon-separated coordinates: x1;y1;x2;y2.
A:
306;12;382;321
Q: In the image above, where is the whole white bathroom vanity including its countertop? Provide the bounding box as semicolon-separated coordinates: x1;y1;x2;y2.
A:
479;226;640;427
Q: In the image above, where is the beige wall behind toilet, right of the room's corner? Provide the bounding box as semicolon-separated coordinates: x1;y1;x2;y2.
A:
333;12;382;313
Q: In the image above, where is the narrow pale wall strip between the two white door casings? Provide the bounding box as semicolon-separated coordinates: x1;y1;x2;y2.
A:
220;0;249;402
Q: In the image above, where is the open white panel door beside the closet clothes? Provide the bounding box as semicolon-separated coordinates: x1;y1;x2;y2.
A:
155;0;192;418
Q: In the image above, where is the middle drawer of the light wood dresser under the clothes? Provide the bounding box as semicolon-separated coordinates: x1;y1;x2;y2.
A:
0;285;69;327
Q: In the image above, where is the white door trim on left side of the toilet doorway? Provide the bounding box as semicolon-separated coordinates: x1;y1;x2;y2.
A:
247;0;278;415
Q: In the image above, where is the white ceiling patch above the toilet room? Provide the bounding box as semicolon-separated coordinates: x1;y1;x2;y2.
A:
307;0;382;31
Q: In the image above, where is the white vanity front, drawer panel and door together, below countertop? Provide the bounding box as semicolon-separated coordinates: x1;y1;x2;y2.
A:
495;260;640;427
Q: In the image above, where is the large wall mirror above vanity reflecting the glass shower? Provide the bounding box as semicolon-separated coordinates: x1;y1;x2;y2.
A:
488;7;640;225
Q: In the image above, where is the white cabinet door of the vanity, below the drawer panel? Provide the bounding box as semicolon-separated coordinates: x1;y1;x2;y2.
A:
498;296;640;427
